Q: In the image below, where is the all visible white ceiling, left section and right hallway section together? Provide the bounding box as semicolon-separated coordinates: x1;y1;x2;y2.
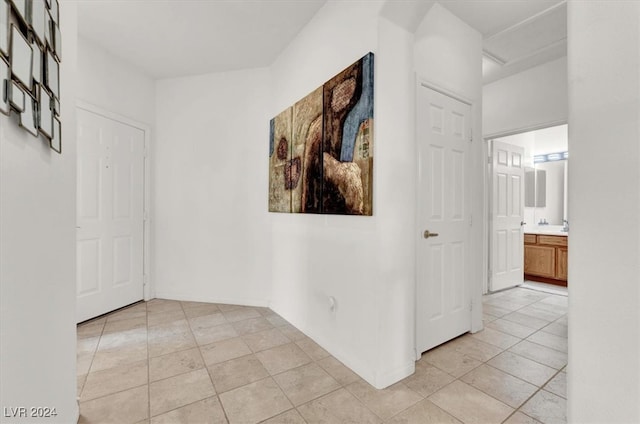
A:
78;0;567;83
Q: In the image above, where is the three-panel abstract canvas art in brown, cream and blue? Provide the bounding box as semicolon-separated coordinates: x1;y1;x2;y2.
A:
269;53;373;215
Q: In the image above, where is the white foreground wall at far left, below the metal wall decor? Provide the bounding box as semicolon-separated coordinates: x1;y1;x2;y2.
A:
0;2;78;424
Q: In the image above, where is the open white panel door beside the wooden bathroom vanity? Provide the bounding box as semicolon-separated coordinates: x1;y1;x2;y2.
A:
489;140;524;291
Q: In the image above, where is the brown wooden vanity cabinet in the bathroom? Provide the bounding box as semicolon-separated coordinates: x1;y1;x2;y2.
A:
524;232;567;287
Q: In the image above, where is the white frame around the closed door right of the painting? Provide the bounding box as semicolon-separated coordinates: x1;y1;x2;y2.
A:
413;78;478;361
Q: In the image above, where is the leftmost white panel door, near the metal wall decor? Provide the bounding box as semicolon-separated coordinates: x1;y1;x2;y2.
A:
76;108;145;322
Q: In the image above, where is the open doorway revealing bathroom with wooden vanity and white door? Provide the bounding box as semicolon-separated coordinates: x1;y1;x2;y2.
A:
485;124;569;294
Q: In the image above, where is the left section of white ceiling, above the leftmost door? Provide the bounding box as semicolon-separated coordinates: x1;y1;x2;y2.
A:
78;0;326;78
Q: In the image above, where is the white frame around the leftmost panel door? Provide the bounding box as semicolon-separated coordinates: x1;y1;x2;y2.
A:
76;100;155;301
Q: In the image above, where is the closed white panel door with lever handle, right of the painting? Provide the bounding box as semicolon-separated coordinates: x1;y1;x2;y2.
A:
416;85;472;355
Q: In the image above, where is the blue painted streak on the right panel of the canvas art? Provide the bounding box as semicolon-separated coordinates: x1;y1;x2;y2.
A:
340;53;373;162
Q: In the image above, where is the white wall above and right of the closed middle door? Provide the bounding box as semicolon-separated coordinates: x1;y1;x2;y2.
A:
414;4;486;331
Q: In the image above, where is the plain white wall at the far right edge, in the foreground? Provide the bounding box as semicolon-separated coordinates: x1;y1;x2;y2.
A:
568;1;640;423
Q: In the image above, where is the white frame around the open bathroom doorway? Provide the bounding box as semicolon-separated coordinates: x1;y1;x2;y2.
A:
482;119;569;295
